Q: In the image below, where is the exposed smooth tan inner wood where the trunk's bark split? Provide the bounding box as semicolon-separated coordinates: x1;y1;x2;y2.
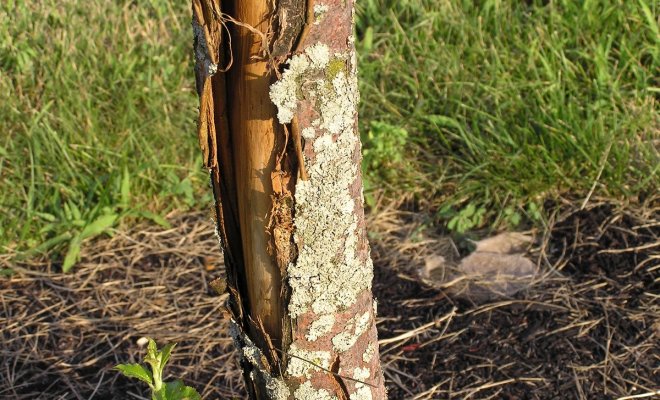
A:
227;0;283;346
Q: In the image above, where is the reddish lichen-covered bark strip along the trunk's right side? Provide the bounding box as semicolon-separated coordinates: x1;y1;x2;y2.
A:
260;0;385;400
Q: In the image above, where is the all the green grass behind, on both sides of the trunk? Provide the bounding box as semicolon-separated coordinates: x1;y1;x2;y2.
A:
0;0;660;263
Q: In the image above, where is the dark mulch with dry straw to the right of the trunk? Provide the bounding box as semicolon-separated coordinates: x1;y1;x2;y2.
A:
372;204;660;399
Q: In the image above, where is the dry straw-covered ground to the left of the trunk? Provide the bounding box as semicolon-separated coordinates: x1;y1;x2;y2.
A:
0;215;243;400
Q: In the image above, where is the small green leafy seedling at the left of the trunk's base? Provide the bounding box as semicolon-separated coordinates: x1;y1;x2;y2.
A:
115;338;202;400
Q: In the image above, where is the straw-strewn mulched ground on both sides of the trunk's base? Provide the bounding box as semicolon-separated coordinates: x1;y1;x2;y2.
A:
0;198;660;400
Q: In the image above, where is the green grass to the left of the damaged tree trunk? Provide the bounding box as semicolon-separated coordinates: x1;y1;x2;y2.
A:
0;0;210;258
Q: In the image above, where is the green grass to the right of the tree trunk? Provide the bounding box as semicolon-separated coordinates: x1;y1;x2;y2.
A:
358;0;660;228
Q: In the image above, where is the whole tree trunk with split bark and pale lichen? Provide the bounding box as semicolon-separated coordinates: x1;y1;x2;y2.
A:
193;0;386;400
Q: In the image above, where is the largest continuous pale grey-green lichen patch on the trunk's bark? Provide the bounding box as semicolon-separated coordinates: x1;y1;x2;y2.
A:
270;44;373;318
